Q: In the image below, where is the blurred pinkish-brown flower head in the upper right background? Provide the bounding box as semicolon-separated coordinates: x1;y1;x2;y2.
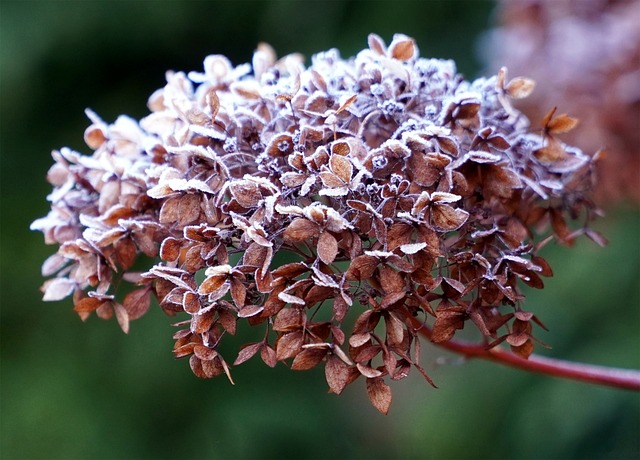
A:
483;0;640;203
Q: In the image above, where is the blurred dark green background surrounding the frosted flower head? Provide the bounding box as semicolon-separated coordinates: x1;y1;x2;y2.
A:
0;0;640;460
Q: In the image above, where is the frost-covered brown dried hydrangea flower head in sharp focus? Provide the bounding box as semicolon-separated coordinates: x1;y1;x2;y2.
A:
32;35;597;412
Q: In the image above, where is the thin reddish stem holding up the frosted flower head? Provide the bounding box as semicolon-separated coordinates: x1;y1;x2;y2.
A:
412;318;640;391
